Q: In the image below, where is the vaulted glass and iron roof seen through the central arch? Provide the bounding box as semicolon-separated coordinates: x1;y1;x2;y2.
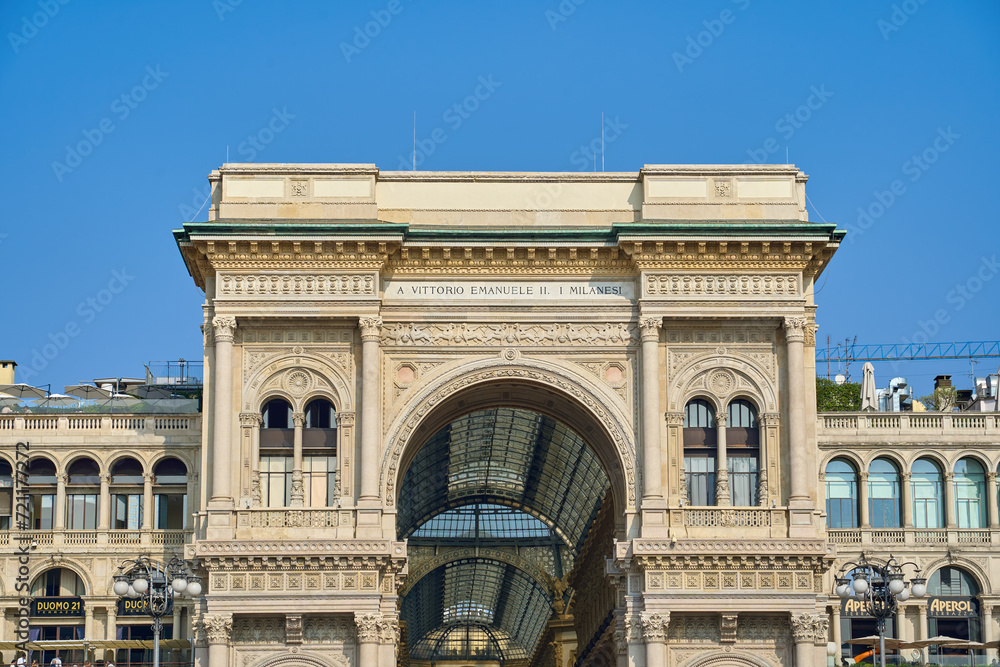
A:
397;407;610;661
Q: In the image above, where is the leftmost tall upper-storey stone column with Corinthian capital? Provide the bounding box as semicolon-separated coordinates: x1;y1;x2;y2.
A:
209;317;236;506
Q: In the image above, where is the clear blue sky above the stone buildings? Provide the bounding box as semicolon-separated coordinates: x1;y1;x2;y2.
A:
0;0;1000;393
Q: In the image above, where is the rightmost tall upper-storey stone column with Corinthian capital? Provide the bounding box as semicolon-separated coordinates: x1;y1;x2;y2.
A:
785;317;813;508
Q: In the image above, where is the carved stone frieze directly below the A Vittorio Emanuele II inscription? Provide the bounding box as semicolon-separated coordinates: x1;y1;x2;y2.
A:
382;322;638;347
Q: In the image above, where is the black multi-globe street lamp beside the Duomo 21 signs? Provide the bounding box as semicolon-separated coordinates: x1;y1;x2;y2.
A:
114;556;201;667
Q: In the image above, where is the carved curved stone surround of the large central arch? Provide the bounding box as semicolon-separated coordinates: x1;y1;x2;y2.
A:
380;350;640;516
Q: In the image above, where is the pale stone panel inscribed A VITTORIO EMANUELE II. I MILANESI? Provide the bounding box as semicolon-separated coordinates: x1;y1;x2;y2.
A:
384;279;635;302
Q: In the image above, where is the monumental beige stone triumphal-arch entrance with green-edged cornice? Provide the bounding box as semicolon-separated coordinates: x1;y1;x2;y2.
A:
175;164;842;667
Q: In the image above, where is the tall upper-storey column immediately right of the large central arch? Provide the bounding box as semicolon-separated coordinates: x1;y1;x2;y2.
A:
639;317;663;506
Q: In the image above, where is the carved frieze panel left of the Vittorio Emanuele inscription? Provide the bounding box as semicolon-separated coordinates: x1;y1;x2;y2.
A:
217;273;377;297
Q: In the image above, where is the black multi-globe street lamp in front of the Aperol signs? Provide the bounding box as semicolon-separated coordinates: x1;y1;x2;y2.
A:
836;552;927;667
